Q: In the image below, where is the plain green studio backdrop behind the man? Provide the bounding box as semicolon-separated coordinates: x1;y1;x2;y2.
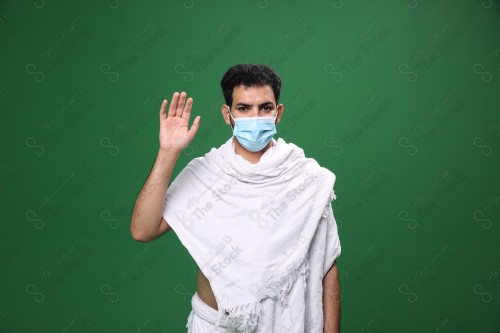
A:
0;0;500;332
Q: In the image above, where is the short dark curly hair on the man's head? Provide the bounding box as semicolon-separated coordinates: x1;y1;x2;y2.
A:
220;64;281;106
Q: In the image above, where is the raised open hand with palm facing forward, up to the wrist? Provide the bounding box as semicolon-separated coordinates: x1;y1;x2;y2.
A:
160;92;200;154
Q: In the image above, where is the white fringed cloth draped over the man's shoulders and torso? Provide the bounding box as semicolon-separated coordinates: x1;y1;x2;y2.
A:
163;137;341;333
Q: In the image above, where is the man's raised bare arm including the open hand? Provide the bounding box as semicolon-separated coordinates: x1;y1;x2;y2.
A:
130;92;200;242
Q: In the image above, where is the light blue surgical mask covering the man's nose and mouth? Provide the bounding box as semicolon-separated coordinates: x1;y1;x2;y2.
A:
229;108;278;152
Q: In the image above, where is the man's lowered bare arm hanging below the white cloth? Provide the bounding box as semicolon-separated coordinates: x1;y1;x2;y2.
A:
323;261;340;333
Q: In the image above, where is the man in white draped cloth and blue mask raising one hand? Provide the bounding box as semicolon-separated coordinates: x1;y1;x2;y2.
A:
130;64;340;332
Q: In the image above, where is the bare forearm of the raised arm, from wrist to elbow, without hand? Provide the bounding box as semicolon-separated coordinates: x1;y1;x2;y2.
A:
130;149;179;240
